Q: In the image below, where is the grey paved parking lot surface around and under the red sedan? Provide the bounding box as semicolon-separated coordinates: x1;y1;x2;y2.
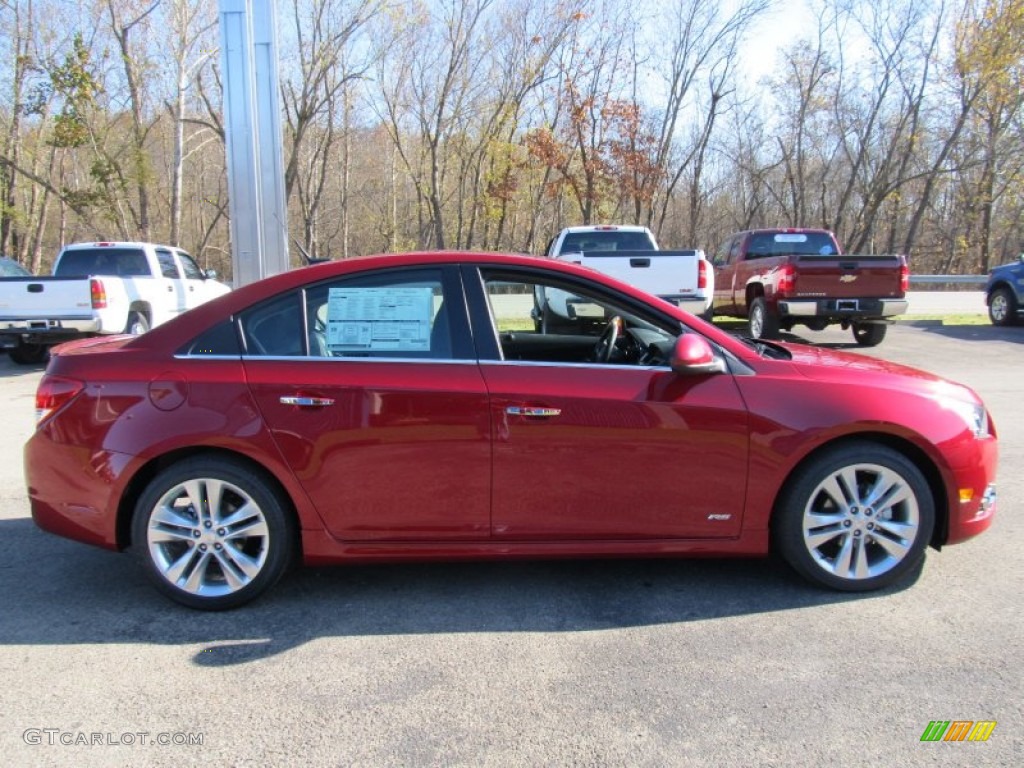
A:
0;319;1024;766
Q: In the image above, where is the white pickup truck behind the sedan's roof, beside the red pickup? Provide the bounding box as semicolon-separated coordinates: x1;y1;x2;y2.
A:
534;224;715;331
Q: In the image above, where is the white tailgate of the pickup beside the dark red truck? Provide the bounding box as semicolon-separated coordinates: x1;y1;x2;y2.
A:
558;251;699;297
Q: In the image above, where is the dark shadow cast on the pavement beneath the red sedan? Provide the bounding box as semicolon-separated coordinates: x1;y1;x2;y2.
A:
0;518;920;667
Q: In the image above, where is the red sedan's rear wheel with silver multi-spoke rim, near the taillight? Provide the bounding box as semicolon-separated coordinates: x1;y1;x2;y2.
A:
132;457;296;610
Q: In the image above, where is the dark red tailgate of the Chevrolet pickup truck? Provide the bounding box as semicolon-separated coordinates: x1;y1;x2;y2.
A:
790;255;903;299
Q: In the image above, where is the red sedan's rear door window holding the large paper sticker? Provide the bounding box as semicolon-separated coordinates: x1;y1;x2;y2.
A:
305;268;453;359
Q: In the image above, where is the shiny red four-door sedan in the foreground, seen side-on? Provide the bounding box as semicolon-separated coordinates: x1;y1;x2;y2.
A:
25;253;996;609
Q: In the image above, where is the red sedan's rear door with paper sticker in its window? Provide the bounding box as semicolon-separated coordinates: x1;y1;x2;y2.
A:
242;269;490;541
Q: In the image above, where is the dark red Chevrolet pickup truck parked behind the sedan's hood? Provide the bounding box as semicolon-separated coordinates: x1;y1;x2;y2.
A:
712;229;909;346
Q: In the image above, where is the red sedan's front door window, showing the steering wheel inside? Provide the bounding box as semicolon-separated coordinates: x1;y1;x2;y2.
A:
483;272;681;366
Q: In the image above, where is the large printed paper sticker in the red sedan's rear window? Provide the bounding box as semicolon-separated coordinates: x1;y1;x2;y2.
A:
327;286;433;353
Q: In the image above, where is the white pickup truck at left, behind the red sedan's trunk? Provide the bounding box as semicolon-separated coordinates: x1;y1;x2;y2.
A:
0;243;230;365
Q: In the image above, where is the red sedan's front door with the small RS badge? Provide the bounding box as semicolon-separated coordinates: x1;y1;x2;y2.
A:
467;264;749;540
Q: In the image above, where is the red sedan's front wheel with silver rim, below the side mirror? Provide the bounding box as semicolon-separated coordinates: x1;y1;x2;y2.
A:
772;441;935;592
